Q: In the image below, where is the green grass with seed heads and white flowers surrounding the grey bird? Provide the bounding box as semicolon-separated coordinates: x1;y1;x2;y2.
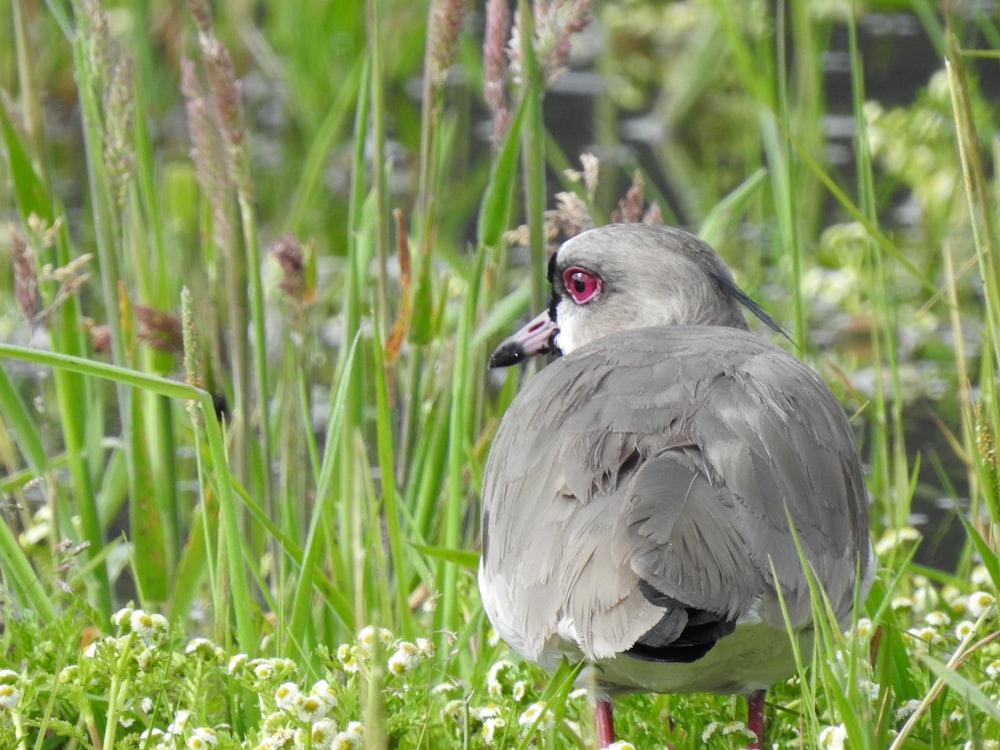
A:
0;0;1000;750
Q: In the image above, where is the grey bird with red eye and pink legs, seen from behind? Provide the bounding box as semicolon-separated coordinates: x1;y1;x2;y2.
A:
478;224;874;748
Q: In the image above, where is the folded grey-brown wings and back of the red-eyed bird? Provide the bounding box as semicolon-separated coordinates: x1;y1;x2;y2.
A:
480;327;867;659
